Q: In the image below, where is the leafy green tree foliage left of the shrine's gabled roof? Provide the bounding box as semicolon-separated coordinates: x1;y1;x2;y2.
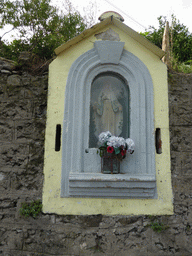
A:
0;0;86;60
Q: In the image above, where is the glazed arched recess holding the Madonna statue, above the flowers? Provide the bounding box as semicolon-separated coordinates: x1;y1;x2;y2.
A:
89;73;129;148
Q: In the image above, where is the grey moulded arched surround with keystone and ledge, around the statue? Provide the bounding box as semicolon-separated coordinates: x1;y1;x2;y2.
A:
61;41;156;198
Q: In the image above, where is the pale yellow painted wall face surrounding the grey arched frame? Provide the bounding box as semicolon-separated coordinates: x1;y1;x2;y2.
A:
43;19;173;215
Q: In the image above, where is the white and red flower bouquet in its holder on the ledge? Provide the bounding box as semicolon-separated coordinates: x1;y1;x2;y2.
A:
99;131;135;173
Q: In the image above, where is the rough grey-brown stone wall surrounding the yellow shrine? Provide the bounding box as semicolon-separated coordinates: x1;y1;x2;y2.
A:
0;57;192;256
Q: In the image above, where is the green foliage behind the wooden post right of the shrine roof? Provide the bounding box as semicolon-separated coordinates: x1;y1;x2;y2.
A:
141;15;192;63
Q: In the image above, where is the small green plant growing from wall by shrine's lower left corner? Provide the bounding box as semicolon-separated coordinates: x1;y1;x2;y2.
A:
19;200;42;218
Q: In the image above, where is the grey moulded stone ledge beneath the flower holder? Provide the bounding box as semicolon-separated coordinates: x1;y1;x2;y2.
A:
69;173;156;198
